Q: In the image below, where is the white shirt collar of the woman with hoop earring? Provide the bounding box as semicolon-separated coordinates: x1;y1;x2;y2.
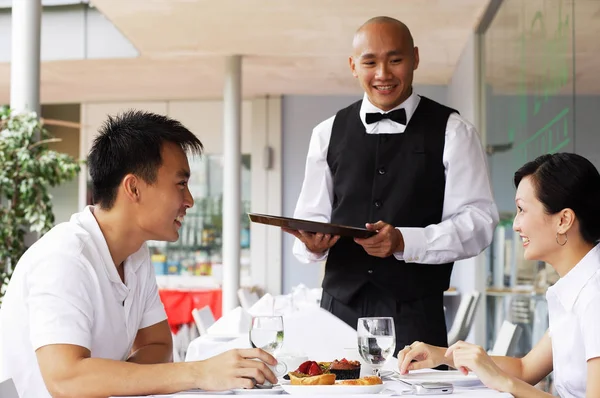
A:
546;244;600;311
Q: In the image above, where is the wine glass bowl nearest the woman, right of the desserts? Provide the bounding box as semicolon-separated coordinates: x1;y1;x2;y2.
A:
356;317;396;376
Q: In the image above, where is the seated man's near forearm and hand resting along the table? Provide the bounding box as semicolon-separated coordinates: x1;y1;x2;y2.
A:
36;344;277;398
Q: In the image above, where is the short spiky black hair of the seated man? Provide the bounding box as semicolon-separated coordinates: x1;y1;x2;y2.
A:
87;110;203;209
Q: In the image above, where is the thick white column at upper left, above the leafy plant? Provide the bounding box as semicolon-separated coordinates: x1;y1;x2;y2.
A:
10;0;42;116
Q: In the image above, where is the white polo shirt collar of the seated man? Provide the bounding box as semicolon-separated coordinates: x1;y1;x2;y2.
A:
71;206;145;283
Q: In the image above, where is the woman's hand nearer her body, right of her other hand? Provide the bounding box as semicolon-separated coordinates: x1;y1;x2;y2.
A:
445;341;511;391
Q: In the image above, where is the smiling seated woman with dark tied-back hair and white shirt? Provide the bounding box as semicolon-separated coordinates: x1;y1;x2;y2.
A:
398;153;600;398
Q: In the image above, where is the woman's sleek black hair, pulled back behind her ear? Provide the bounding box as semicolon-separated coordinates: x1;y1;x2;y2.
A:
515;153;600;243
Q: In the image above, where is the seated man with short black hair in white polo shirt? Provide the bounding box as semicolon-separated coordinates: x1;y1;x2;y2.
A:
0;111;277;398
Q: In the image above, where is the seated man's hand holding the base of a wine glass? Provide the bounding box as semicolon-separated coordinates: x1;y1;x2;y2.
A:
189;348;277;391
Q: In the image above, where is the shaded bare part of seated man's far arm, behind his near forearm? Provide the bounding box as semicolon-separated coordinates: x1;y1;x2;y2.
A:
127;321;173;364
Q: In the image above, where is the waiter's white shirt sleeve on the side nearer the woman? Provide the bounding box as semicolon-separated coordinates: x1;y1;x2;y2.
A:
394;114;498;264
